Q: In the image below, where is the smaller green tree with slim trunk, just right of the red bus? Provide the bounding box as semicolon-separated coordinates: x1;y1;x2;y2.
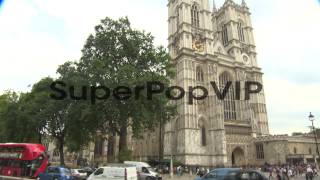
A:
29;76;89;165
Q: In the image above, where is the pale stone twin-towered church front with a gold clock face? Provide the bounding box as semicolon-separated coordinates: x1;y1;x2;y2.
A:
164;0;269;166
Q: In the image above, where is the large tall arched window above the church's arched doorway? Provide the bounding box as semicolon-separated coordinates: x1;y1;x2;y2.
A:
219;72;236;120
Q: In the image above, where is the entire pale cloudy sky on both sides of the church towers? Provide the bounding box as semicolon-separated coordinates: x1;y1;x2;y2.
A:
0;0;320;134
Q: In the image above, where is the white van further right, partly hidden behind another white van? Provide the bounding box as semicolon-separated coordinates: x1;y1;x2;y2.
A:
124;161;162;180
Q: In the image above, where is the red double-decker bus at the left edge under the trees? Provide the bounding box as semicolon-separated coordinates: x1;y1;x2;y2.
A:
0;143;48;178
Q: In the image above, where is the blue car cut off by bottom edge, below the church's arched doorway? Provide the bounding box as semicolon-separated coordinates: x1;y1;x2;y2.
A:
195;168;268;180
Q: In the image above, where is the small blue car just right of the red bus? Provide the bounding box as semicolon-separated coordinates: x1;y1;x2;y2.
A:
38;166;75;180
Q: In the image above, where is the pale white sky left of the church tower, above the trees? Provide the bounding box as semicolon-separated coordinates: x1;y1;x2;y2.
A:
0;0;167;91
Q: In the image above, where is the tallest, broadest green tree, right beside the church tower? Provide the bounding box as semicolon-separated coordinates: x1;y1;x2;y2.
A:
78;18;175;160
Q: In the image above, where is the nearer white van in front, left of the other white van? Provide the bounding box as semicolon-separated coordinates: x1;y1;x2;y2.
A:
88;164;138;180
